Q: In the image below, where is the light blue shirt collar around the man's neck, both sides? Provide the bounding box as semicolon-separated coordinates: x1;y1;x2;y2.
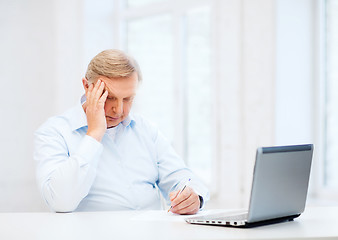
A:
69;95;135;131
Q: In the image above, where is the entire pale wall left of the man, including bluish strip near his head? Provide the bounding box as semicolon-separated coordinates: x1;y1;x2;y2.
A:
0;0;82;211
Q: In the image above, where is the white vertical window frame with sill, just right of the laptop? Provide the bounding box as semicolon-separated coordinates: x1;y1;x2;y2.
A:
310;0;338;205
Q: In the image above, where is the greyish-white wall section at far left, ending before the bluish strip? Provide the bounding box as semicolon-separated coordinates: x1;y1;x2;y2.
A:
0;0;55;211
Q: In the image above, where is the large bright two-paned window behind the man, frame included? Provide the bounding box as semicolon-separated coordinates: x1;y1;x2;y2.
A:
121;0;214;186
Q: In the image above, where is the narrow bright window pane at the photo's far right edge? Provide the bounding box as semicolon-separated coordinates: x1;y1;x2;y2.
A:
325;0;338;187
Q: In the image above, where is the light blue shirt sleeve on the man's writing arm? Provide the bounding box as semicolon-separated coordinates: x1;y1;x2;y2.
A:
155;128;209;207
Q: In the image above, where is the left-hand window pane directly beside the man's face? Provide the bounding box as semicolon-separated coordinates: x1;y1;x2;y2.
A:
127;15;174;140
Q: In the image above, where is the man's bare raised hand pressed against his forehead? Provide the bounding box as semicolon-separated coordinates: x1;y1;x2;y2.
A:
85;79;108;142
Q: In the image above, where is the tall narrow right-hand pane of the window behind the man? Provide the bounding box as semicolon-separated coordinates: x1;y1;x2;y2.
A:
186;7;213;183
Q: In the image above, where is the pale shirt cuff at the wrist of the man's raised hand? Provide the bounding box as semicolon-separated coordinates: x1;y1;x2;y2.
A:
76;135;103;166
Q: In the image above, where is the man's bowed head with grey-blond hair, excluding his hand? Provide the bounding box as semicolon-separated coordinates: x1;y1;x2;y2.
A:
82;49;142;128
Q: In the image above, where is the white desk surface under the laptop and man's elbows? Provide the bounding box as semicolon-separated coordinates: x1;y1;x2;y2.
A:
0;207;338;240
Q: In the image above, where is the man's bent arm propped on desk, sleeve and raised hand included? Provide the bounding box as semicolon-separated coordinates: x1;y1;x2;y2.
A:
35;81;107;212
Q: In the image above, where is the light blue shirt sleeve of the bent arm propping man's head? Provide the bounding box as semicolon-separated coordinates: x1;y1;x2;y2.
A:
34;124;103;212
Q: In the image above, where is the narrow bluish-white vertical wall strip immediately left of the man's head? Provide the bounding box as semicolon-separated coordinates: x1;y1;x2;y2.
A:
53;0;85;112
